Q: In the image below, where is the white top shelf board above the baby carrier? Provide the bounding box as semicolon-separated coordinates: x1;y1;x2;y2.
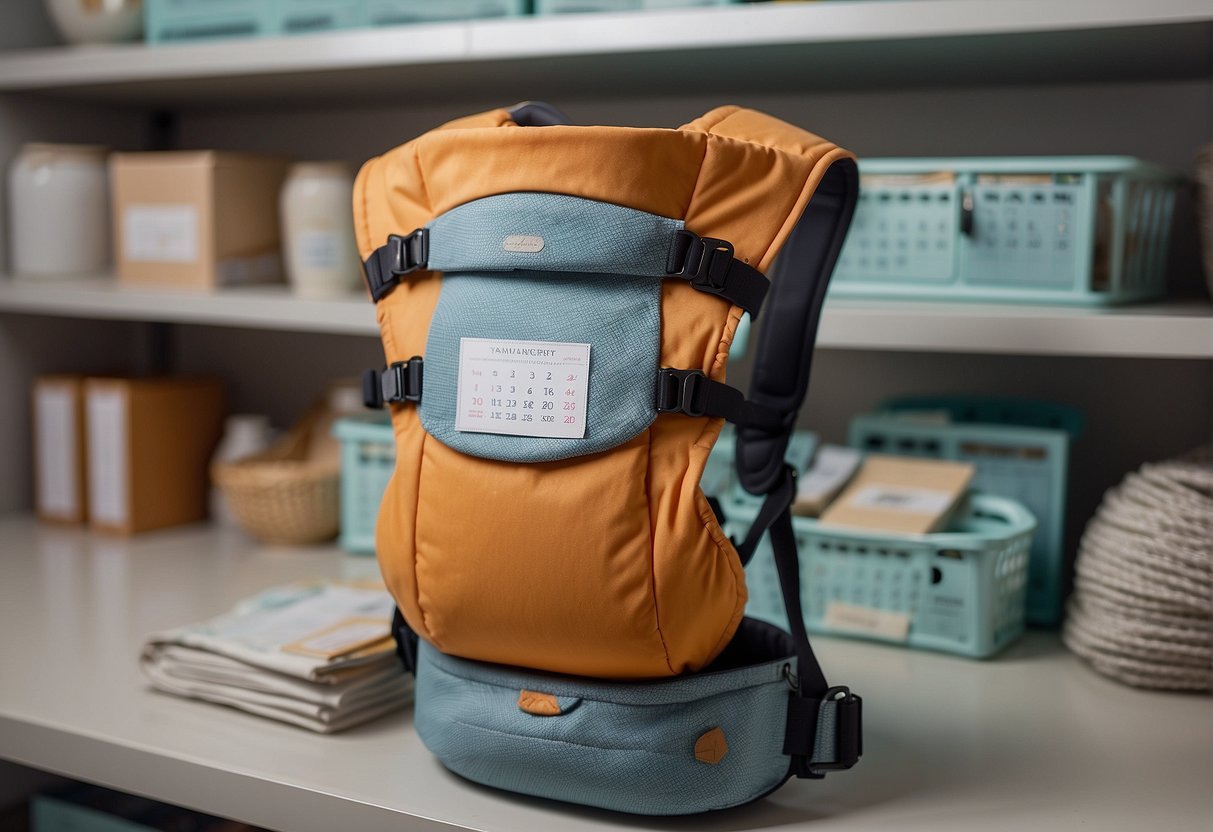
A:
0;0;1213;107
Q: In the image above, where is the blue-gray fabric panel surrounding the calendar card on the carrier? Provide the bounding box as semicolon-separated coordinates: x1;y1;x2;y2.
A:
421;271;661;462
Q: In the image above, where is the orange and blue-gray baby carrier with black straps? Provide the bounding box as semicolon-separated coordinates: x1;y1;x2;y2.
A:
354;103;861;814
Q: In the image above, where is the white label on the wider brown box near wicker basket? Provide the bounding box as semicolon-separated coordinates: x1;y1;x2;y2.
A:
85;389;130;526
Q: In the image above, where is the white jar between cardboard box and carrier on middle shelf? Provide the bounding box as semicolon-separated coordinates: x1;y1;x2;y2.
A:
279;161;361;297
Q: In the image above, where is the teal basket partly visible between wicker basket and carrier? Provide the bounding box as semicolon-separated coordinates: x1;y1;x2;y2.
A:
332;415;395;554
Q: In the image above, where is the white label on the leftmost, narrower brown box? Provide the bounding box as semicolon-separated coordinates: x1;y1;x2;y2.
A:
34;382;80;517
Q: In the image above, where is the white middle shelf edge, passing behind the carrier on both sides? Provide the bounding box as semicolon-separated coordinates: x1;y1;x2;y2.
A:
0;278;1213;359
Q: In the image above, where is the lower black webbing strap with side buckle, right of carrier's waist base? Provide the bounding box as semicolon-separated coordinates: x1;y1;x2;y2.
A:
756;465;864;779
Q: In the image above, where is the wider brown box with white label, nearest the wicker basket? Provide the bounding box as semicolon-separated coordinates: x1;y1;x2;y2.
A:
85;378;223;534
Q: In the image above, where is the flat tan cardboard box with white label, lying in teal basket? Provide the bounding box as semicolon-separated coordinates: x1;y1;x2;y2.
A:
819;454;974;535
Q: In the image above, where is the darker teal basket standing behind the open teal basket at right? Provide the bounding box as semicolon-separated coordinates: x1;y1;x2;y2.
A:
848;397;1084;627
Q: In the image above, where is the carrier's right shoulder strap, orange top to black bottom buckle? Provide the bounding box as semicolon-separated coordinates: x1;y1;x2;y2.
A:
689;108;862;777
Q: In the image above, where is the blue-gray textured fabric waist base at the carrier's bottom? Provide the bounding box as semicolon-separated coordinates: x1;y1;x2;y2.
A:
415;642;788;815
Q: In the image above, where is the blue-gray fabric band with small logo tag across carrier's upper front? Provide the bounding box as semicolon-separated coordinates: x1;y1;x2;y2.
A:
428;193;683;278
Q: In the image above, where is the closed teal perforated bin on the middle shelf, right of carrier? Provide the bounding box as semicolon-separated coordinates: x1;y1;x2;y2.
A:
830;156;1180;304
